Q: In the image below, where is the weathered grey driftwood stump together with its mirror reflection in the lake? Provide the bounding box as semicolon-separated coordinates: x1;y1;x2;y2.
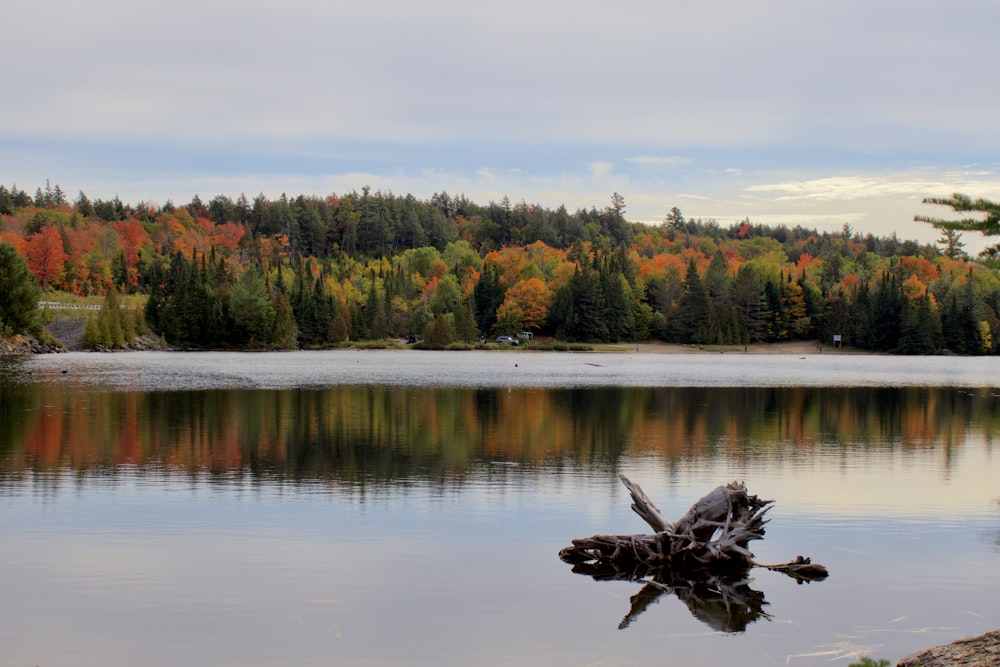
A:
559;475;827;632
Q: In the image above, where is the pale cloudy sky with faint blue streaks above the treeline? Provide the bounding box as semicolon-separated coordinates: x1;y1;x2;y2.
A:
0;0;1000;250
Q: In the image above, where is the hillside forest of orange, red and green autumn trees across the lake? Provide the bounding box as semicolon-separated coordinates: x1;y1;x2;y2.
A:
0;177;1000;354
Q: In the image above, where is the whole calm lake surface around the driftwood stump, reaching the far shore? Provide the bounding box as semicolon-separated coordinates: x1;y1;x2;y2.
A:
0;351;1000;667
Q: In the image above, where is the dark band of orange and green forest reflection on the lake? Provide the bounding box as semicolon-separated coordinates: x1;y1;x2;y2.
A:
0;382;1000;485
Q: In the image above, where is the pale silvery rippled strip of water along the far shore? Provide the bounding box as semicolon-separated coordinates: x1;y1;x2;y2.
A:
15;350;1000;391
